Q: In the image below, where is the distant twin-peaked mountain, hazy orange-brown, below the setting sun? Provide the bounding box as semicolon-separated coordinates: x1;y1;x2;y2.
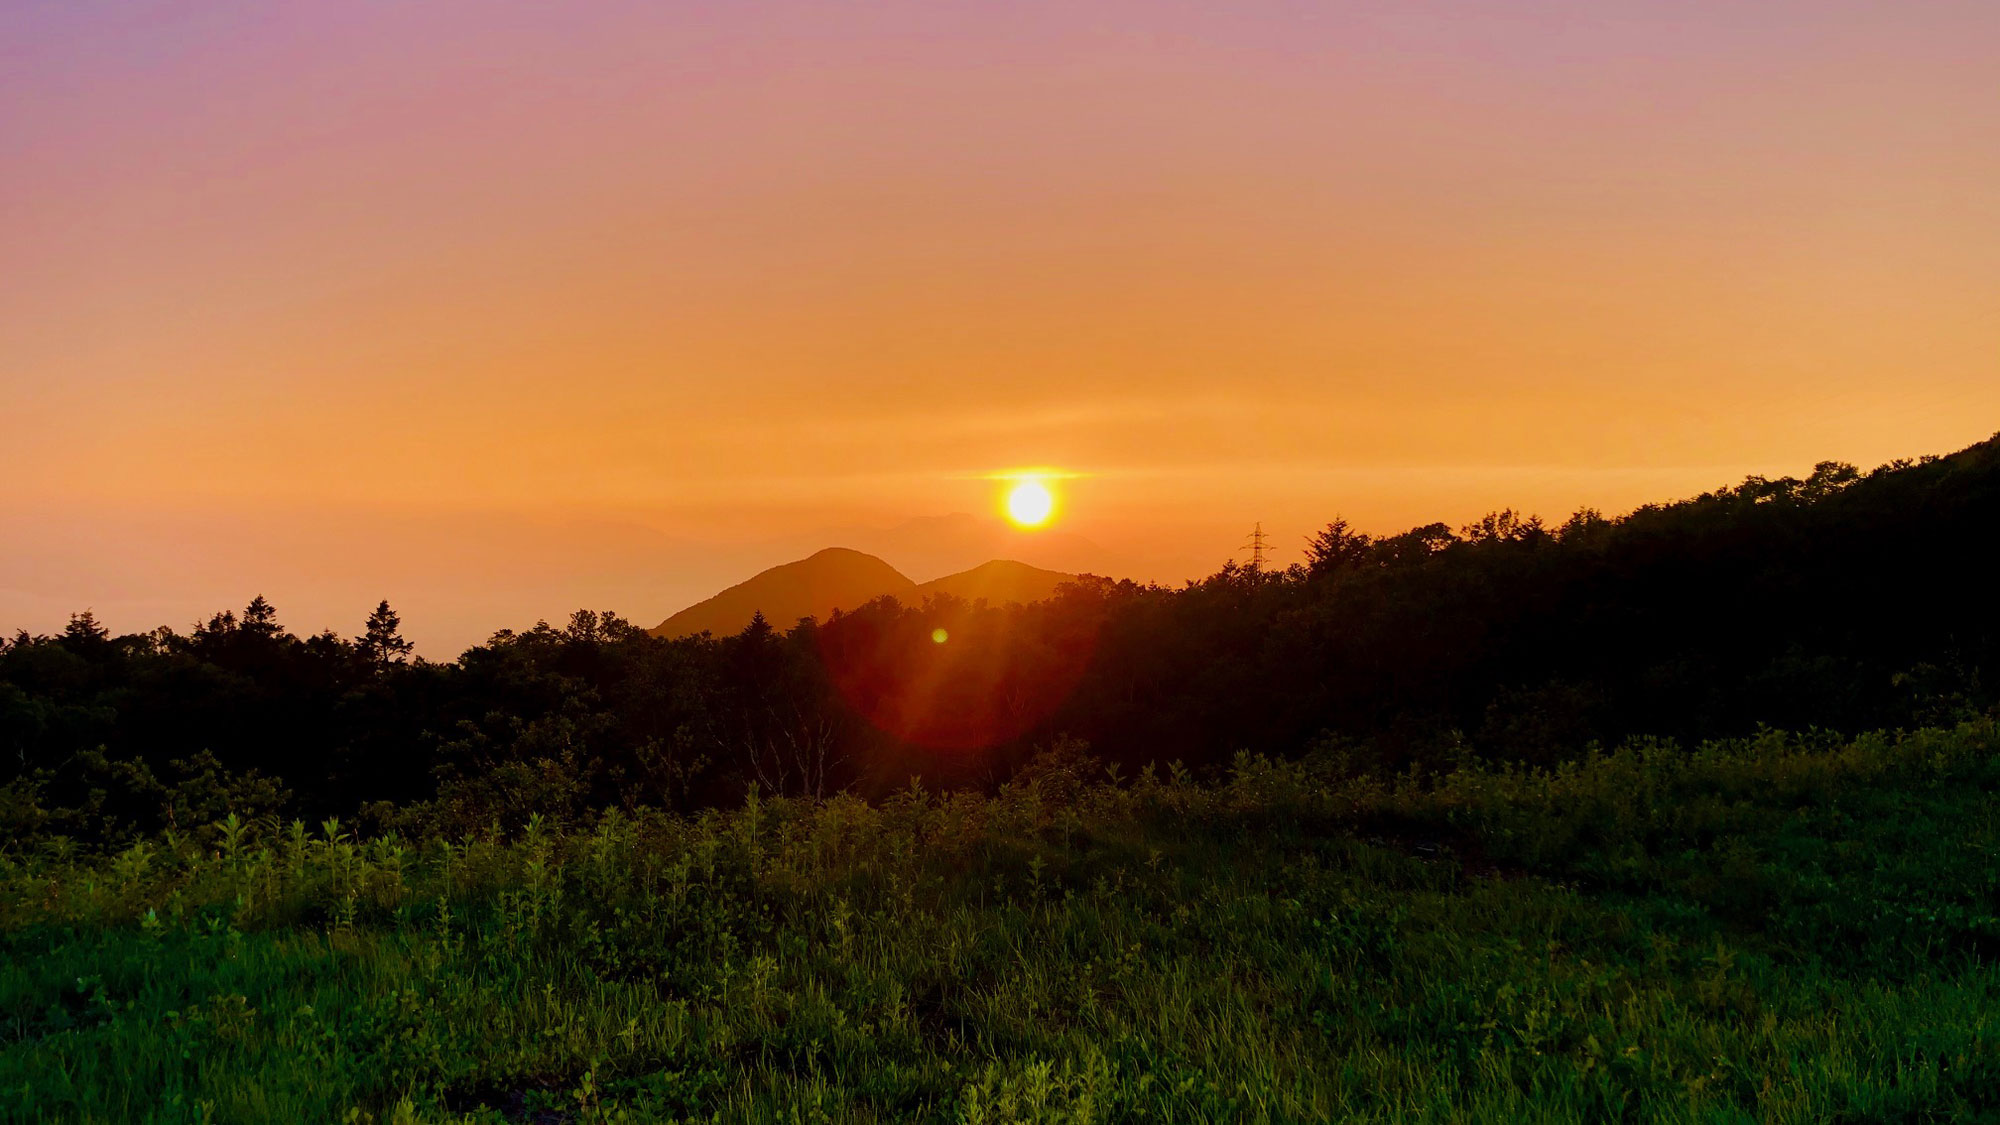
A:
652;546;1076;637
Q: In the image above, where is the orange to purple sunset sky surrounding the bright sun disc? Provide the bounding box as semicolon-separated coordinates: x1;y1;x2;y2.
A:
0;0;2000;659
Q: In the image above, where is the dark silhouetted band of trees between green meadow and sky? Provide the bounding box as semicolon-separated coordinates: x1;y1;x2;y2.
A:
0;430;2000;843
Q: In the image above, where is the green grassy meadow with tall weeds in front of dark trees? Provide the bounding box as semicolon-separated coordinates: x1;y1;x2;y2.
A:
0;721;2000;1123
